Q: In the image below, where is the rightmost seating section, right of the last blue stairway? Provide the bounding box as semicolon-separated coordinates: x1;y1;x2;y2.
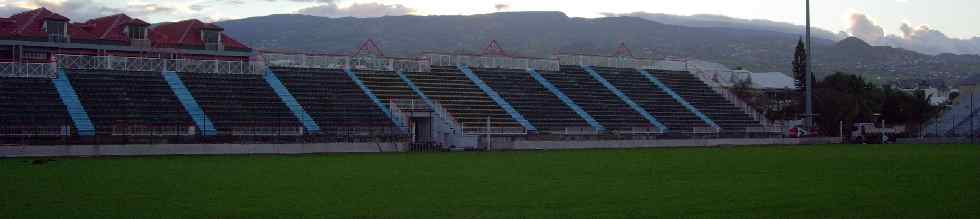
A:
648;70;762;133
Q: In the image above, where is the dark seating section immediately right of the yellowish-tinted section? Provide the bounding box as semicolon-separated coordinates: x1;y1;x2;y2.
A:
473;68;589;134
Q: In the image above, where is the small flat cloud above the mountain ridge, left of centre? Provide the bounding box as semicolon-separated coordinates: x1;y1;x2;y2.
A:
292;0;416;18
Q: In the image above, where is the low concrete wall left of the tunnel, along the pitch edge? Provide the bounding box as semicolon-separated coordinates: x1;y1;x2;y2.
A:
0;143;404;157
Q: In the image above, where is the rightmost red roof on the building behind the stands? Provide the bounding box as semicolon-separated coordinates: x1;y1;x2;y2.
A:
150;19;249;50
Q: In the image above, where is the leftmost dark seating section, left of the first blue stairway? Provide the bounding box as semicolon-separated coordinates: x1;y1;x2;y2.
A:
0;77;72;139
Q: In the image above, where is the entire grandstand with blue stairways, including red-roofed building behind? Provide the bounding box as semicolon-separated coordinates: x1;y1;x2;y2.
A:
0;8;782;149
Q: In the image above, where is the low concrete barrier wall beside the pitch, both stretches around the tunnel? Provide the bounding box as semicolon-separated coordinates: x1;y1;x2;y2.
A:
0;138;840;157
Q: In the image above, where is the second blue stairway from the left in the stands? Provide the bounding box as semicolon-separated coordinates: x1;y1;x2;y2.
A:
163;71;218;136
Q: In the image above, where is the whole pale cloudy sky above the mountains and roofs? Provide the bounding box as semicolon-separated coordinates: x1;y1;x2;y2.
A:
0;0;980;54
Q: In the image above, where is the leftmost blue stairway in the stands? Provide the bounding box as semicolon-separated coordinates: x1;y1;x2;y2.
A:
52;70;95;136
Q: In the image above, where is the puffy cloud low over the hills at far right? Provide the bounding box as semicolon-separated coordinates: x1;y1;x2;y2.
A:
848;13;980;55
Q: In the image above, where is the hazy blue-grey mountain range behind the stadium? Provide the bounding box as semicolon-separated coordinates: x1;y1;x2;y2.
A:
219;12;980;83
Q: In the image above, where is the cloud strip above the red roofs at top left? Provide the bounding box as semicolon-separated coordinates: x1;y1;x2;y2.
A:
0;0;177;21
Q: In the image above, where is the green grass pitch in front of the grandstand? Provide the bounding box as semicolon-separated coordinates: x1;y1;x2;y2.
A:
0;145;980;218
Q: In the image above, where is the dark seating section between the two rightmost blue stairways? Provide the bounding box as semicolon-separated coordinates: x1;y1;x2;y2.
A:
595;67;710;133
